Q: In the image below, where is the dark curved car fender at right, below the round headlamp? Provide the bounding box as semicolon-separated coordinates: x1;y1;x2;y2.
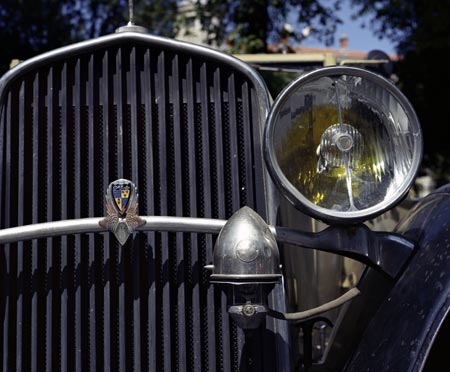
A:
344;185;450;372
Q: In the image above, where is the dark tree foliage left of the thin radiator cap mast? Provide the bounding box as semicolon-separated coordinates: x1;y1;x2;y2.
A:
0;0;132;74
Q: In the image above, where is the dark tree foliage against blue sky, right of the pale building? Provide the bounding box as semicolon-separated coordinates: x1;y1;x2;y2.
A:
197;0;342;53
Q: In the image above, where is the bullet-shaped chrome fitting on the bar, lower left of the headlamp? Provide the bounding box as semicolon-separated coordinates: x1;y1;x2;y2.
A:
206;207;282;329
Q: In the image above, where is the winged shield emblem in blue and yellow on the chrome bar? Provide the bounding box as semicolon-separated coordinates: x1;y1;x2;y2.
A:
100;178;145;245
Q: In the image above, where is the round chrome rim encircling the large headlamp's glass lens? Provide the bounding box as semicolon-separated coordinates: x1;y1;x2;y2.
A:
264;66;423;224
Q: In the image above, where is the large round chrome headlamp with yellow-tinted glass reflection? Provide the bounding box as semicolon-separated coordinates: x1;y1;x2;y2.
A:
264;67;423;224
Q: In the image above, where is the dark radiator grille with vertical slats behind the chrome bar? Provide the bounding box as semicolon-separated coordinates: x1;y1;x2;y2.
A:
0;37;282;372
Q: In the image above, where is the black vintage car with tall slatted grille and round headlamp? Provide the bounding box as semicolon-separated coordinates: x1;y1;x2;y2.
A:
0;18;450;372
